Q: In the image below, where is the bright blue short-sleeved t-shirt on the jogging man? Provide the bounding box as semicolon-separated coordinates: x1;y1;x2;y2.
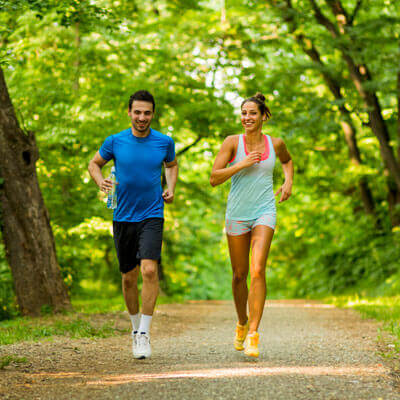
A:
99;128;175;222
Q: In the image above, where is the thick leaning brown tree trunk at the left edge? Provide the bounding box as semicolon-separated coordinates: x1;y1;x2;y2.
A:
0;68;70;315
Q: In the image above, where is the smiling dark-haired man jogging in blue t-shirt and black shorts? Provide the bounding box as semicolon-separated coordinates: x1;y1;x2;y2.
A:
89;90;178;359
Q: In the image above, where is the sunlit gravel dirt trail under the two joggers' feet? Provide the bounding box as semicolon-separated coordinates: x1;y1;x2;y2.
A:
0;300;400;400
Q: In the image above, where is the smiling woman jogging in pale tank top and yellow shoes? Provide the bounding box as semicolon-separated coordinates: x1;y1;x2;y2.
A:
210;93;293;357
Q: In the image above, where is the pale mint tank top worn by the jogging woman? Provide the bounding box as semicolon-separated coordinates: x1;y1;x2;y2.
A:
226;134;276;221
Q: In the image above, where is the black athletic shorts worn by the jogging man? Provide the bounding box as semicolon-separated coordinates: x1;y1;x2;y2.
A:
113;218;164;273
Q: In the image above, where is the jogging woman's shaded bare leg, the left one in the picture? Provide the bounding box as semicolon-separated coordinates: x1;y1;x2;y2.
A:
226;232;251;325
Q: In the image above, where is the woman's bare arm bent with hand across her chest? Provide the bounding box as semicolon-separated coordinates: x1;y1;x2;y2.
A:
210;136;261;186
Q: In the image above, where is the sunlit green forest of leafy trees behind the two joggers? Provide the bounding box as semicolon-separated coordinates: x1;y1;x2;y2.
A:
0;0;400;319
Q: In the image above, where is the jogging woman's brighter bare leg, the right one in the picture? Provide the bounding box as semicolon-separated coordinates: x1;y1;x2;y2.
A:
249;225;274;334
